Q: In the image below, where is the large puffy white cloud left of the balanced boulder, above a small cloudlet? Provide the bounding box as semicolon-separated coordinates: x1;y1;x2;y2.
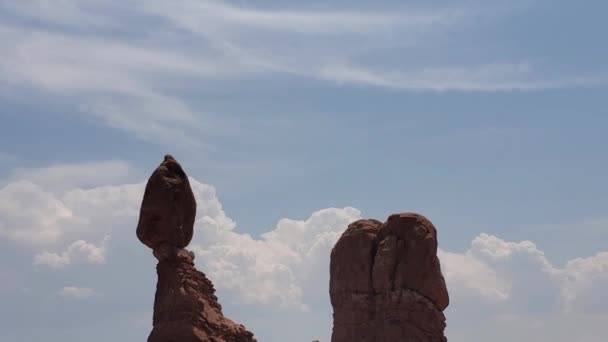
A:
0;167;144;248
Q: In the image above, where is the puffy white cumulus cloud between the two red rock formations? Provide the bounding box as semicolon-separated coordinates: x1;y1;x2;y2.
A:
192;207;360;310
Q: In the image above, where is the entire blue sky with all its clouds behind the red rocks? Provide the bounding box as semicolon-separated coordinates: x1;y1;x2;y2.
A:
0;0;608;342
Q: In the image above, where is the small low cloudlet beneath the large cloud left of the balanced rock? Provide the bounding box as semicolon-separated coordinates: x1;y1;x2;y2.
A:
33;235;110;268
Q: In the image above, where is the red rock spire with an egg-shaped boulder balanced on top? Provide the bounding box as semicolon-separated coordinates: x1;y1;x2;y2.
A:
137;155;256;342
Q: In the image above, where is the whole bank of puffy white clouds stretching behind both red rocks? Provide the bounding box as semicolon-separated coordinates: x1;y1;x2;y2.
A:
0;160;608;342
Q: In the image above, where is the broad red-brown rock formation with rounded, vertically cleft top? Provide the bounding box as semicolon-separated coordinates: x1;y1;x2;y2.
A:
329;213;449;342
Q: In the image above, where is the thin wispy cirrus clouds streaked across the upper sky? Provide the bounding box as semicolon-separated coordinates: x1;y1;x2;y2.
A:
0;0;603;147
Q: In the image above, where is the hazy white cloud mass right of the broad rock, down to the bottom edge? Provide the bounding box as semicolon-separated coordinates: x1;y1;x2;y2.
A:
439;234;608;342
